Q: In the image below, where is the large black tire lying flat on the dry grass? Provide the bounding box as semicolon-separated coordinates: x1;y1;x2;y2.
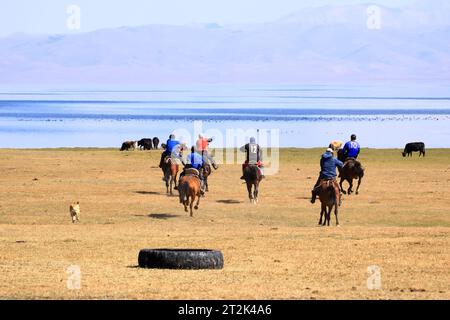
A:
138;249;223;269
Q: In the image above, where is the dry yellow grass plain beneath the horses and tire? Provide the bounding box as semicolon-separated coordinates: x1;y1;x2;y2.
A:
0;149;450;299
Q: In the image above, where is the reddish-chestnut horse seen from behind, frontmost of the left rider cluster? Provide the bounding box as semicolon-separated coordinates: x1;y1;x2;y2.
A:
178;168;201;217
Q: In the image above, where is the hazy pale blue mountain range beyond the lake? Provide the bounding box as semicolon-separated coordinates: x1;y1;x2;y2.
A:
0;0;450;85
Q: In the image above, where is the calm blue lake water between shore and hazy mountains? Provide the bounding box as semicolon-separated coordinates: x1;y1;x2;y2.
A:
0;85;450;148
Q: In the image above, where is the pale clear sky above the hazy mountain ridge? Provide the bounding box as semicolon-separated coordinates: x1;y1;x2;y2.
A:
0;0;413;36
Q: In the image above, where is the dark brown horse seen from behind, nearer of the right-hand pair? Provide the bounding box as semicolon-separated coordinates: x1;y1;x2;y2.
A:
318;179;341;226
